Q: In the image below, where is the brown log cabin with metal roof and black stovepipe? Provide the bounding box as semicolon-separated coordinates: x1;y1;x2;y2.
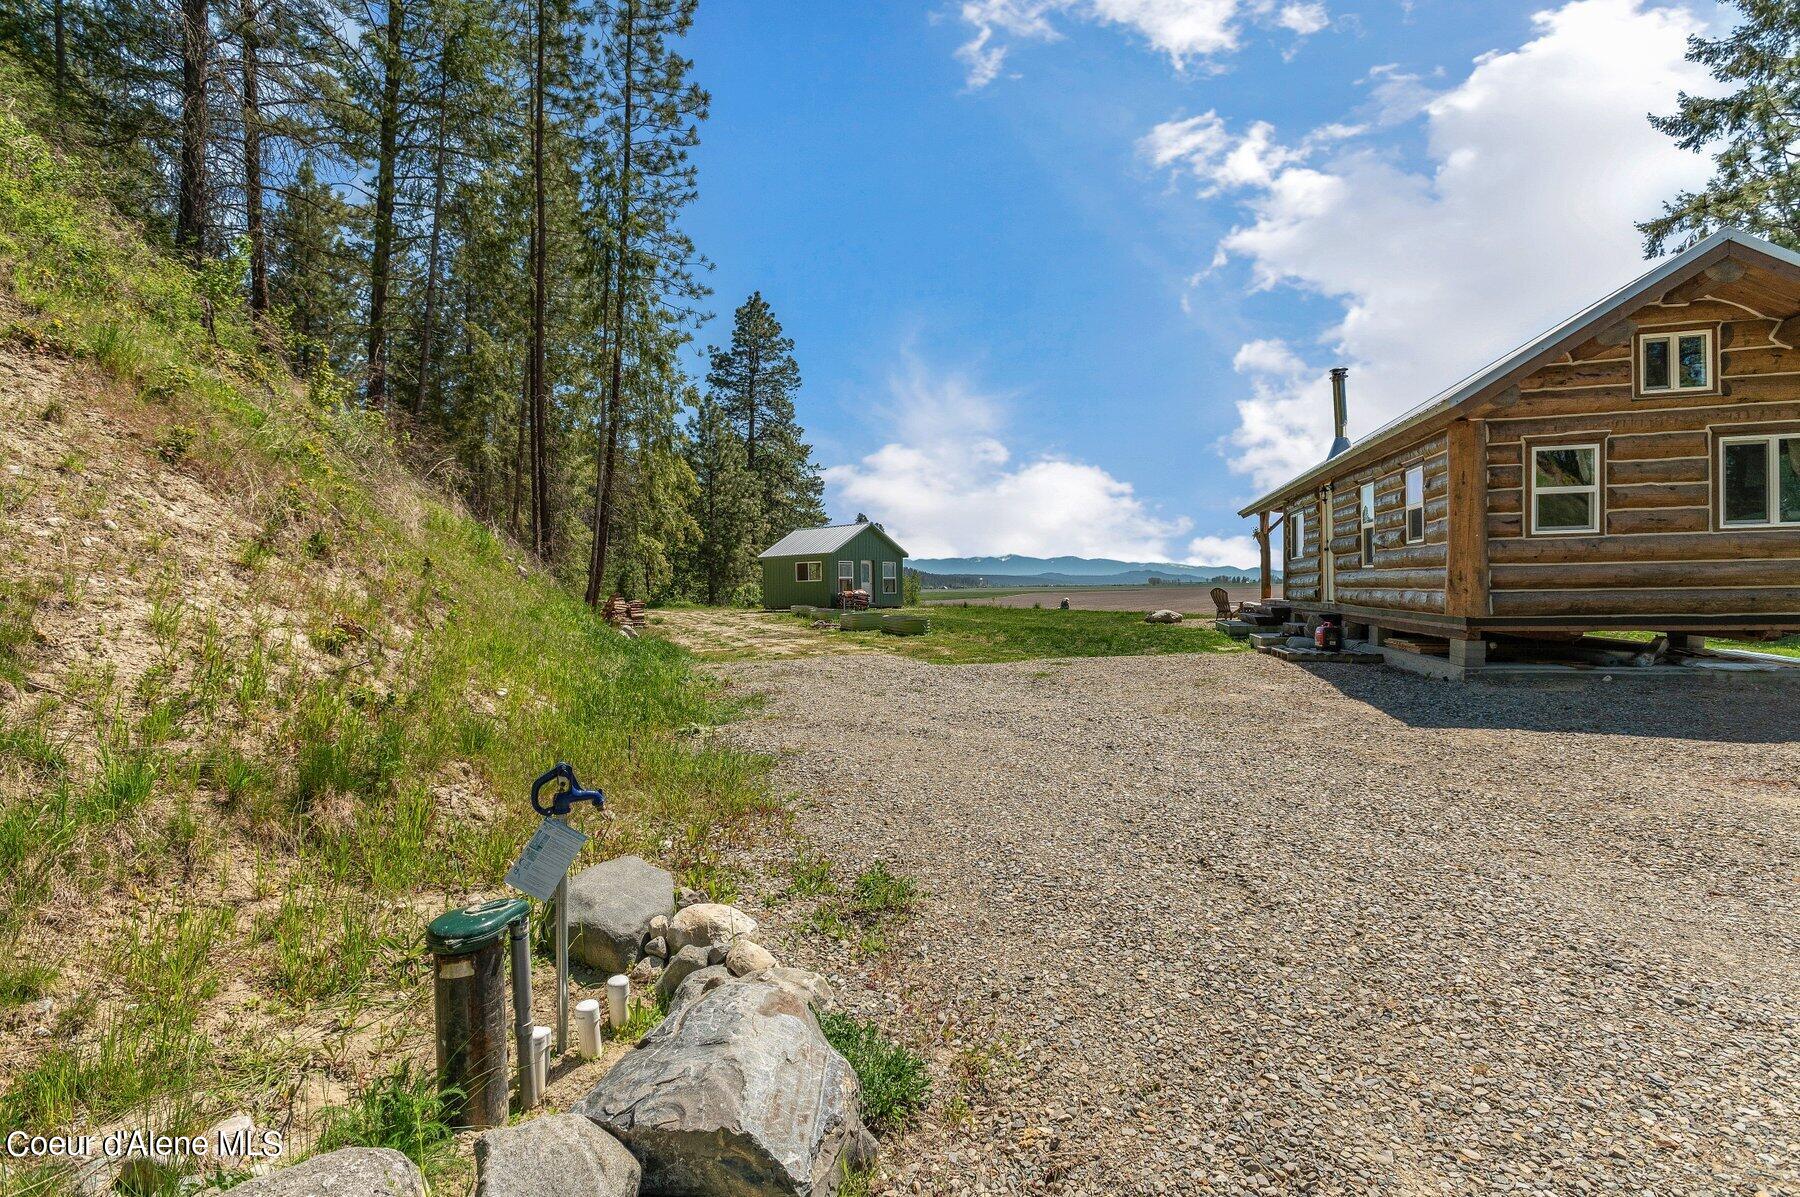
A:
1240;230;1800;675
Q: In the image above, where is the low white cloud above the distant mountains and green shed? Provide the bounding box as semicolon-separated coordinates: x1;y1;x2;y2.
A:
824;358;1202;565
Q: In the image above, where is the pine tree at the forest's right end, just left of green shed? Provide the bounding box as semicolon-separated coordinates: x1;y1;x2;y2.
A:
706;292;824;551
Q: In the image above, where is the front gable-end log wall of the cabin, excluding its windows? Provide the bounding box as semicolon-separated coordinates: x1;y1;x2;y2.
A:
1483;283;1800;619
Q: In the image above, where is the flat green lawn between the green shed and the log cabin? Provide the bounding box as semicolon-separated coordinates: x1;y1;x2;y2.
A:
795;607;1244;664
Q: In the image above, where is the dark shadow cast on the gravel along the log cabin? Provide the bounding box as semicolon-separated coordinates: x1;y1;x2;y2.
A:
1298;664;1800;743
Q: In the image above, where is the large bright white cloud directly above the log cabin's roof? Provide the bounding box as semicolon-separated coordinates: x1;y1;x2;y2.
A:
1139;0;1712;486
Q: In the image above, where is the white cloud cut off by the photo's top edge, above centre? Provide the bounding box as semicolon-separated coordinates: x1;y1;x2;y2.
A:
956;0;1330;88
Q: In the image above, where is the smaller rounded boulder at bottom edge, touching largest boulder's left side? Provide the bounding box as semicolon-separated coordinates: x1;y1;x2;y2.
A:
475;1114;643;1197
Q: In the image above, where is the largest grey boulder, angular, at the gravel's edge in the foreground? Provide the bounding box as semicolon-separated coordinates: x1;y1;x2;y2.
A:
576;970;875;1197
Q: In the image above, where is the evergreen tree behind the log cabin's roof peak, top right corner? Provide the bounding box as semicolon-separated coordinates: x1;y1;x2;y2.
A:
1638;0;1800;257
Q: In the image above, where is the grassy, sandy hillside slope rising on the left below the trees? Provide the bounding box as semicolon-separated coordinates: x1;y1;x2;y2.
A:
0;59;770;1192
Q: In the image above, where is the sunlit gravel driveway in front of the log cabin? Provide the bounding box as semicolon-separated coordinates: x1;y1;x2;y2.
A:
724;653;1800;1197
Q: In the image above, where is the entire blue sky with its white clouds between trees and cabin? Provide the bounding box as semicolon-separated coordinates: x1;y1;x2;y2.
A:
689;0;1719;563
